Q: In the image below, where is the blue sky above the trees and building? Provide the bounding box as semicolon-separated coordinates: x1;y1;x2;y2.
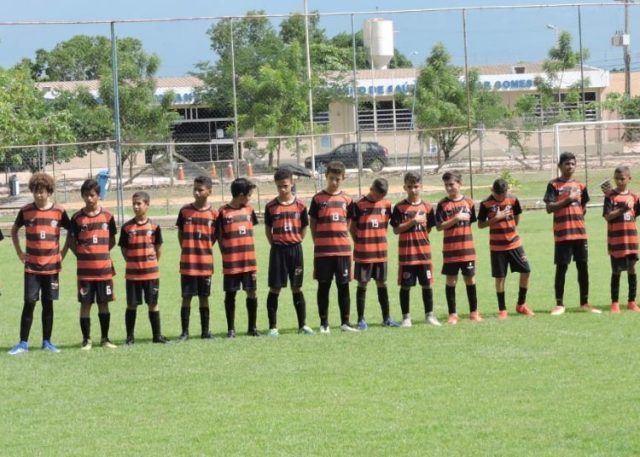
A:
0;0;640;76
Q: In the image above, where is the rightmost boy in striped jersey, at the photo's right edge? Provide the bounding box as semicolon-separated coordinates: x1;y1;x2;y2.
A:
602;166;640;313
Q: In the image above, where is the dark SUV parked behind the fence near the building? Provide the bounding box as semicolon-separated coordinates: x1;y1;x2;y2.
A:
304;141;389;173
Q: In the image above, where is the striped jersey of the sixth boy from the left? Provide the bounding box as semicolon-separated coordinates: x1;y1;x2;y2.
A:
264;198;309;245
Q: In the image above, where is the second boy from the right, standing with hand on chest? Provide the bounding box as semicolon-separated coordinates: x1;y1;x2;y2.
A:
544;152;601;316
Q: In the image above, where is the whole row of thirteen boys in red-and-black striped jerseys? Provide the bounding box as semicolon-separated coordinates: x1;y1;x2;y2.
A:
2;153;640;354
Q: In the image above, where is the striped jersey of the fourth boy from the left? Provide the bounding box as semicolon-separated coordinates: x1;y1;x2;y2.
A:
176;203;218;276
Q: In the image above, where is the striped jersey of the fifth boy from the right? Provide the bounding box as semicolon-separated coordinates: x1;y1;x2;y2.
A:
391;199;436;265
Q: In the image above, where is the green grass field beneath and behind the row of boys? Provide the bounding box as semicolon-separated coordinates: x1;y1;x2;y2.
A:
0;208;640;456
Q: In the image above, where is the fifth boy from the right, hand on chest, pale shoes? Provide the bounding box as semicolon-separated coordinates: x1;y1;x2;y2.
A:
391;171;441;327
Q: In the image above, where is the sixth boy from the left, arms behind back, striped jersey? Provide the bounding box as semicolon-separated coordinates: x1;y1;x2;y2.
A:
264;168;313;336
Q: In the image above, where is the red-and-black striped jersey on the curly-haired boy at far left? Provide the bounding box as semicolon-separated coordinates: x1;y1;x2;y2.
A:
14;203;70;275
